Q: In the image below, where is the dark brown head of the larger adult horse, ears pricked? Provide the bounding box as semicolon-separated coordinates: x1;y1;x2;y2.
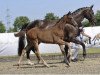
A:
83;5;96;25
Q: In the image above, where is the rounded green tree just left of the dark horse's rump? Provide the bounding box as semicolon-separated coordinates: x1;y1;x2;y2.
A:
13;16;30;31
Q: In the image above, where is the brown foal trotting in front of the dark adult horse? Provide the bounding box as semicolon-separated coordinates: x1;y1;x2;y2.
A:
18;13;77;67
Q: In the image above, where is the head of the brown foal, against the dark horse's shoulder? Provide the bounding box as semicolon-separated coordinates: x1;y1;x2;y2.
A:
64;11;78;27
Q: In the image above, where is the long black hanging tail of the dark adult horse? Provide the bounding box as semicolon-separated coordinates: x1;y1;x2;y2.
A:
18;36;25;56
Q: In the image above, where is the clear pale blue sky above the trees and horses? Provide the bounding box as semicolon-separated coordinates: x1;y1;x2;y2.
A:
0;0;100;26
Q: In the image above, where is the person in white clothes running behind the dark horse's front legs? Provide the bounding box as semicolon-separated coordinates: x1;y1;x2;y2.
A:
71;27;91;62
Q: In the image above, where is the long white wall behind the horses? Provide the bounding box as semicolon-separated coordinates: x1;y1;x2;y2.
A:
0;26;100;56
